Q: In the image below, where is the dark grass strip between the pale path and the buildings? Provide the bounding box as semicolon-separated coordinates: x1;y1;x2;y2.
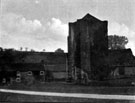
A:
0;82;135;95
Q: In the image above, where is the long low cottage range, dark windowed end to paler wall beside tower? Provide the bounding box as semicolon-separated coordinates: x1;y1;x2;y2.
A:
11;63;66;82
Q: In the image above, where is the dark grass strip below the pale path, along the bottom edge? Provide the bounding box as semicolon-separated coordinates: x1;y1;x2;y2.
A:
0;93;135;103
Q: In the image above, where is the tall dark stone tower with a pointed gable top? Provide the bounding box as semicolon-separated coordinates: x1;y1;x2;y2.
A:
68;14;108;79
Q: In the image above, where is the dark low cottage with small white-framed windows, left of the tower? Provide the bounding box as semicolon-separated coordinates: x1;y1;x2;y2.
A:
1;63;45;83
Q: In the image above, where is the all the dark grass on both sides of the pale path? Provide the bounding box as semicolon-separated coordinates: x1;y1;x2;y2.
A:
0;82;135;103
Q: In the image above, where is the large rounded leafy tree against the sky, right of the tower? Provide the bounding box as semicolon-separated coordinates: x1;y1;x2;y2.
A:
108;35;128;50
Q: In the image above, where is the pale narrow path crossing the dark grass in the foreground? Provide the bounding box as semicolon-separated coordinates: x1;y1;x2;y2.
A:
0;89;135;100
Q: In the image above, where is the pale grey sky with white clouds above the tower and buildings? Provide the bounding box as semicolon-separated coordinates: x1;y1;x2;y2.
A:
0;0;135;54
